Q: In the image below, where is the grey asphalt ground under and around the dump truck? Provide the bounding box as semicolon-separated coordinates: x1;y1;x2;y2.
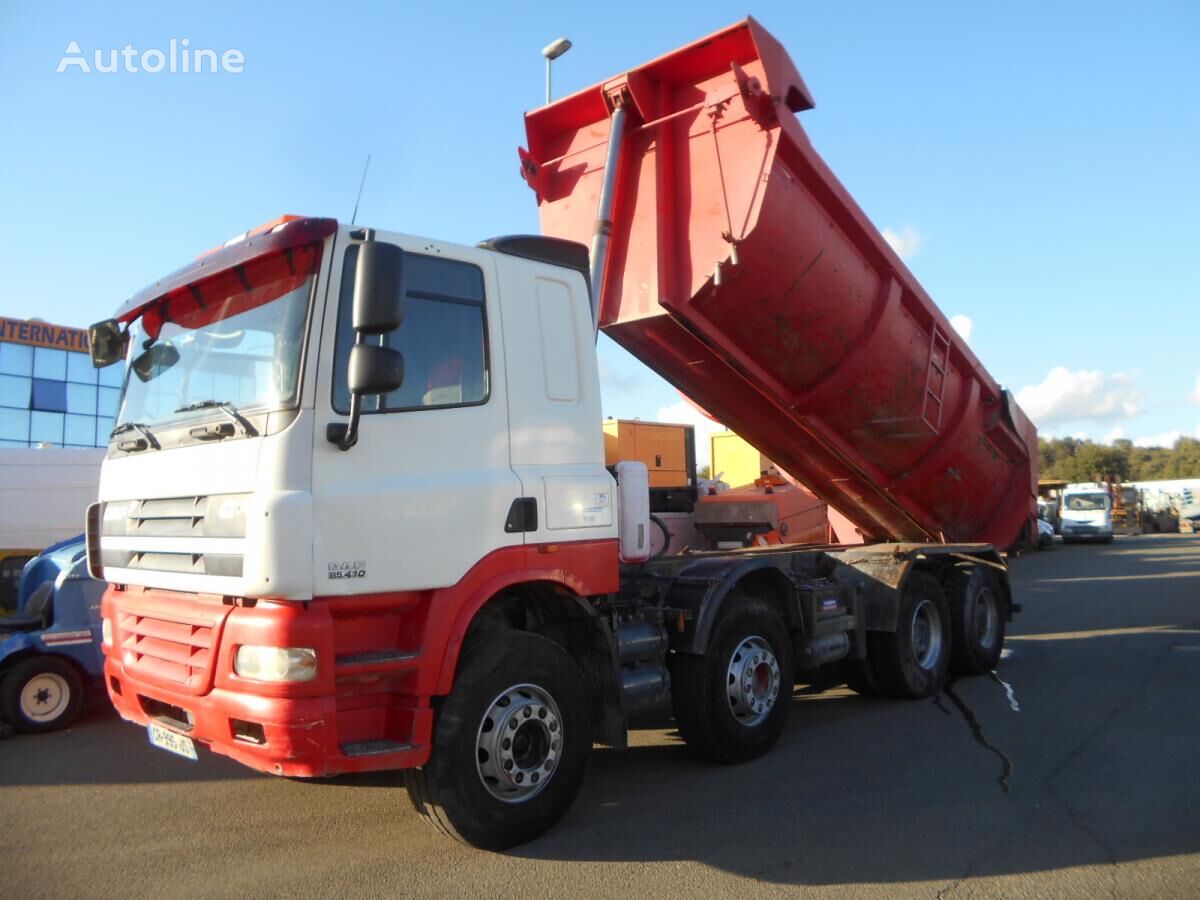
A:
0;535;1200;898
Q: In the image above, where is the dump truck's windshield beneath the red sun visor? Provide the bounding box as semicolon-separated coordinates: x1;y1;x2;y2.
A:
116;244;319;428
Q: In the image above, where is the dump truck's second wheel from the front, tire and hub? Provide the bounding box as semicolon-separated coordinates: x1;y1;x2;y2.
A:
670;594;796;763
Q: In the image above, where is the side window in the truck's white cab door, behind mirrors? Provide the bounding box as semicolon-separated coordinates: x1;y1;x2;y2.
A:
334;244;488;413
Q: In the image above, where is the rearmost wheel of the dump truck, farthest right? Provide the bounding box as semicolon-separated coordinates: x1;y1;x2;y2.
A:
942;565;1004;674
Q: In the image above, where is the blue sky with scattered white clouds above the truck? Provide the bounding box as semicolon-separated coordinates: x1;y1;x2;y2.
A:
0;0;1200;465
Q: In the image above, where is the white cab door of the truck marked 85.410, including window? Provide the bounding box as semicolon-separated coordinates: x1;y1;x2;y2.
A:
312;232;523;595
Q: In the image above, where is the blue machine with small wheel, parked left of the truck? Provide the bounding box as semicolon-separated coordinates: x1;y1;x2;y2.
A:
0;535;104;733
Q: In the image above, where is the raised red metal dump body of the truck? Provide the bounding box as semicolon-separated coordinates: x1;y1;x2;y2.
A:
521;19;1037;547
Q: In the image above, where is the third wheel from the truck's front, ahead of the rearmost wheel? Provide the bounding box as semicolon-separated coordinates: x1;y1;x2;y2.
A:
866;572;950;698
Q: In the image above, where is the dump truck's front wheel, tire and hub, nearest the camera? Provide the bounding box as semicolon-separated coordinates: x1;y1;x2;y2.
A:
404;631;592;850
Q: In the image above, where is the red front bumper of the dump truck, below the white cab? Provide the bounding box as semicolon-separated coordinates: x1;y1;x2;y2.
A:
103;589;433;778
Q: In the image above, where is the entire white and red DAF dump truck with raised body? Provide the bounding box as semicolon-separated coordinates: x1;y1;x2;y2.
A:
88;19;1037;848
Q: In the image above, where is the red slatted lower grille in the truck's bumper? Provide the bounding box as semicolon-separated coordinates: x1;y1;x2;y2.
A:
118;613;216;692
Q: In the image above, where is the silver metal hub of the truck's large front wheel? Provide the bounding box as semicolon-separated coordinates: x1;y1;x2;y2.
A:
475;684;563;803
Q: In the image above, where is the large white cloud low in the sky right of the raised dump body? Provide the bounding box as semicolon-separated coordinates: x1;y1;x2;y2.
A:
1016;366;1141;428
